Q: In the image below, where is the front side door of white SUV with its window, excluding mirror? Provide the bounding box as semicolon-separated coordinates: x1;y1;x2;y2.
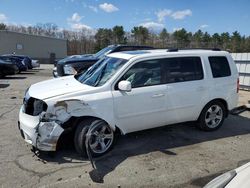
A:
112;60;166;133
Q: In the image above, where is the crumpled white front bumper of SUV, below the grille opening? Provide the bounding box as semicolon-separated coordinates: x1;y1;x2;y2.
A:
18;106;64;151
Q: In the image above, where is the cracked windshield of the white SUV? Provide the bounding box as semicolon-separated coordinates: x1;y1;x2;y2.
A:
75;57;127;87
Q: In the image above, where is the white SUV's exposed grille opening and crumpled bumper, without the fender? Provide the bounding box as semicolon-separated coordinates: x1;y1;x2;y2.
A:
19;97;64;151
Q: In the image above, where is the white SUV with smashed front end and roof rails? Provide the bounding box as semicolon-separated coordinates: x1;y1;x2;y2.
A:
19;50;238;156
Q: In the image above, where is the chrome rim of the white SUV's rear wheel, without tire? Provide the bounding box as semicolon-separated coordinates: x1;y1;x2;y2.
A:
205;105;223;128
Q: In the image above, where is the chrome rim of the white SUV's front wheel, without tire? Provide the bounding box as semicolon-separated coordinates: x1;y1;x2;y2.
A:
89;122;114;153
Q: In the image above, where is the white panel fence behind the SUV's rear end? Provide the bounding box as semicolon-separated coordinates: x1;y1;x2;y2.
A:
231;53;250;90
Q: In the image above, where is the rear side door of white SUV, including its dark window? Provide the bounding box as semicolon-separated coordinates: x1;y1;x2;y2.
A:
164;57;209;124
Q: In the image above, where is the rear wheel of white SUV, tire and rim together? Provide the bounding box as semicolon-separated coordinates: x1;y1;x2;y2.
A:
197;101;226;131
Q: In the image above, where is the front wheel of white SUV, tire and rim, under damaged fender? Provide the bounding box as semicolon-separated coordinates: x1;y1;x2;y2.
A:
74;119;115;157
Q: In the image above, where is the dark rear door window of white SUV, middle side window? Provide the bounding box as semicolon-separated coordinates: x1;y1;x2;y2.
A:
163;57;203;83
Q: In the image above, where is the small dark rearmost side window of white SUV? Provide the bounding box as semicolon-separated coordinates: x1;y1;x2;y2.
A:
208;56;231;78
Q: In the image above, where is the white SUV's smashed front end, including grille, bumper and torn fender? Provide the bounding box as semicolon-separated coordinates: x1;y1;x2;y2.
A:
19;94;93;151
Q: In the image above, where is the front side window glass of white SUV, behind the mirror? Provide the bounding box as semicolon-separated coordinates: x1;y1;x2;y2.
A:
120;60;163;88
